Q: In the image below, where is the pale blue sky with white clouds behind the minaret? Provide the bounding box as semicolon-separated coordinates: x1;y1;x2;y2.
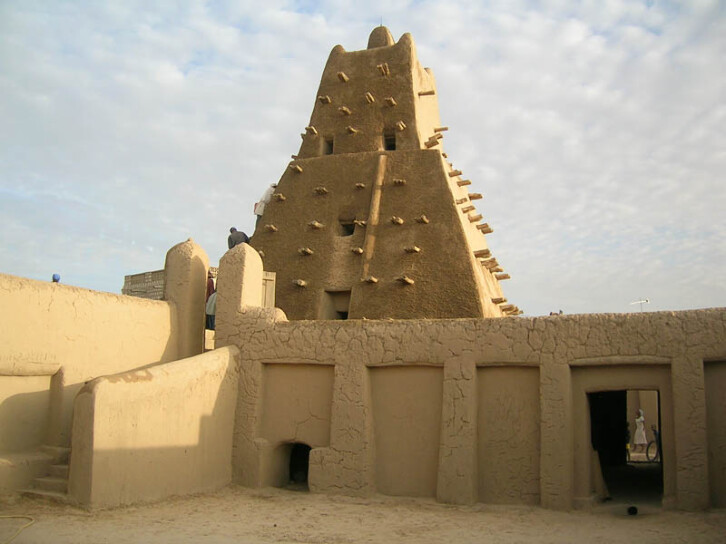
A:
0;0;726;315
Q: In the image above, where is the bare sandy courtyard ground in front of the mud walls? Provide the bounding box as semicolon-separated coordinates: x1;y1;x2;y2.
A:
0;486;726;544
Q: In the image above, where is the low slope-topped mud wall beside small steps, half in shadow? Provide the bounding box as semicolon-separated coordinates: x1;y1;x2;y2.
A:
69;347;239;507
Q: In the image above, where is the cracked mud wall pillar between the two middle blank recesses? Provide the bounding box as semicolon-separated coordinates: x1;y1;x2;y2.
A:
436;356;479;504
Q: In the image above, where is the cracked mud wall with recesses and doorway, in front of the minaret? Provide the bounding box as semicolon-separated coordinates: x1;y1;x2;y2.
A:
217;246;726;509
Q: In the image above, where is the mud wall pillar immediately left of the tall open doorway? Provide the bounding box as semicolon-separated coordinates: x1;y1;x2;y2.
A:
540;361;574;510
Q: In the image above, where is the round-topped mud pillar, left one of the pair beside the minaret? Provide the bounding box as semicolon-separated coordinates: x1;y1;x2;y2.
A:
164;238;209;359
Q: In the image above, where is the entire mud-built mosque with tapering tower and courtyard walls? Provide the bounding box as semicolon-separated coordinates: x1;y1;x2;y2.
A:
0;27;726;510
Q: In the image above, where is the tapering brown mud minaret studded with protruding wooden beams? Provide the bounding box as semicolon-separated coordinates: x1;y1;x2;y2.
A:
251;26;519;319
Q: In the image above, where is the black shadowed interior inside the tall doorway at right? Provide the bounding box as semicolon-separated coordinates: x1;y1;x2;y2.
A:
587;390;663;503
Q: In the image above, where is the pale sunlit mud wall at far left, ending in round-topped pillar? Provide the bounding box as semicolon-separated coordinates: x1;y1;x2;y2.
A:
0;240;208;453
